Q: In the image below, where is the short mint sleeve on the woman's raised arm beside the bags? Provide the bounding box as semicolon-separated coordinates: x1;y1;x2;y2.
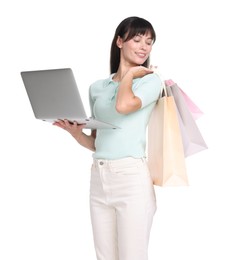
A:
133;73;162;108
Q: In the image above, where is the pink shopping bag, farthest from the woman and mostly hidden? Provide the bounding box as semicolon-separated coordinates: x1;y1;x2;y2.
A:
164;79;204;120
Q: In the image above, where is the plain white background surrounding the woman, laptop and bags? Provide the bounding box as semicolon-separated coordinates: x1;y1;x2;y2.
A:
0;0;232;260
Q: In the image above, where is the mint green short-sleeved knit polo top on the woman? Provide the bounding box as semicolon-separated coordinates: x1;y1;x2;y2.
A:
89;73;161;160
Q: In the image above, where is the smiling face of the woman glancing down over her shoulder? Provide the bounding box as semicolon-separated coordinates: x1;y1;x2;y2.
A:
117;33;153;66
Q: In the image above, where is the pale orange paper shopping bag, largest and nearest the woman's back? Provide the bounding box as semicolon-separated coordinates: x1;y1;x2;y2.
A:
147;84;188;186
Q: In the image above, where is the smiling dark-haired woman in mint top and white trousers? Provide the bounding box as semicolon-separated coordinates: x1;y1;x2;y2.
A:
54;17;161;260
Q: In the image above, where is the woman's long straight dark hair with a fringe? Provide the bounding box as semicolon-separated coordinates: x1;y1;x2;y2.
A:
110;16;156;73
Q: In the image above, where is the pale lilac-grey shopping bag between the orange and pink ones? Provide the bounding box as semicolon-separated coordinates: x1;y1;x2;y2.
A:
166;84;208;157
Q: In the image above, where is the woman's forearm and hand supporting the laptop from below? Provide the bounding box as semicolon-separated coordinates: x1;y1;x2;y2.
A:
53;120;96;151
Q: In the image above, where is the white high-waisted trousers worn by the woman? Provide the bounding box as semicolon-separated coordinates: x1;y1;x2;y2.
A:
90;157;156;260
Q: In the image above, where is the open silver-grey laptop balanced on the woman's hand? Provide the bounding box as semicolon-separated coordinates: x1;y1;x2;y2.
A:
21;68;118;129
